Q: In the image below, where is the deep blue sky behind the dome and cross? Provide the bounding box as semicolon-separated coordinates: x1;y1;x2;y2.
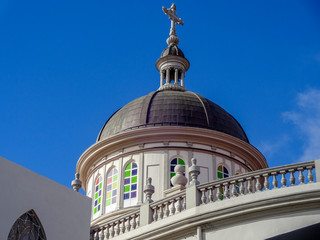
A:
0;0;320;186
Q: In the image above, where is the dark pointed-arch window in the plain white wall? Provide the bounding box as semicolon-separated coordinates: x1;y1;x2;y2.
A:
8;210;47;240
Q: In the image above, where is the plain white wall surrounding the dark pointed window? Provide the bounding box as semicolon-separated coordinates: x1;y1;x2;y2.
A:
0;157;91;240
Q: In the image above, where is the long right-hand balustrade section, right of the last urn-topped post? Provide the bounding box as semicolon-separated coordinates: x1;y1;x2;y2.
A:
198;161;315;204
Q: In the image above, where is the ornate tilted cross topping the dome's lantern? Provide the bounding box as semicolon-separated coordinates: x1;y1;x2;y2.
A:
162;3;184;45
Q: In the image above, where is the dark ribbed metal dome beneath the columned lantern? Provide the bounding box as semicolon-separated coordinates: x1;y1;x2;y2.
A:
97;90;249;143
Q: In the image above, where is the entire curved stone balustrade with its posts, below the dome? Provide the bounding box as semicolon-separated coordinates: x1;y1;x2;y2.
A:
90;160;320;240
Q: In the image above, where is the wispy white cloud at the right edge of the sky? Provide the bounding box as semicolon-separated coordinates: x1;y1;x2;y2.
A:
283;89;320;162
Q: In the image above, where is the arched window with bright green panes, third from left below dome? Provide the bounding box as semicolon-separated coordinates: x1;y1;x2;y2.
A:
123;162;138;207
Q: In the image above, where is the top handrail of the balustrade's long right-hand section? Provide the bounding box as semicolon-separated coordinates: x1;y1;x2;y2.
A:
198;161;315;190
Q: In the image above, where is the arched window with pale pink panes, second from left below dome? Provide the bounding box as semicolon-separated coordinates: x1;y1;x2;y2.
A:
106;168;118;212
